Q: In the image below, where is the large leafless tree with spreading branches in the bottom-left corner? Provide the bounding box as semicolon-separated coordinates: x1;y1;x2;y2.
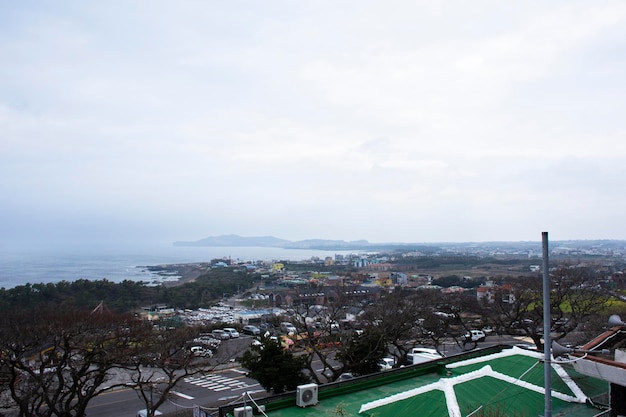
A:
0;307;133;417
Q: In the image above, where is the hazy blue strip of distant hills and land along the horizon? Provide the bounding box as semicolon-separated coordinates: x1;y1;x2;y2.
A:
174;234;626;254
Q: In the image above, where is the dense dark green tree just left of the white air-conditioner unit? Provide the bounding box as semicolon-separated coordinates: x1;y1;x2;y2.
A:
240;336;310;394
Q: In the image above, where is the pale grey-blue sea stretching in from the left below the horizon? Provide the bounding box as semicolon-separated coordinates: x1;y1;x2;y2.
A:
0;240;350;289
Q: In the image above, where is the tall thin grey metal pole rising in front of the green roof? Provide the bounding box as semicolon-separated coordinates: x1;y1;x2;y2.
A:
541;232;552;417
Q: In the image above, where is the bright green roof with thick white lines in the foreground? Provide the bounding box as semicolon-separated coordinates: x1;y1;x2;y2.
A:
225;347;608;417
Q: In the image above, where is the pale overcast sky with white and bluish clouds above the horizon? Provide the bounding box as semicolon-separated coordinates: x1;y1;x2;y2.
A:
0;0;626;243
